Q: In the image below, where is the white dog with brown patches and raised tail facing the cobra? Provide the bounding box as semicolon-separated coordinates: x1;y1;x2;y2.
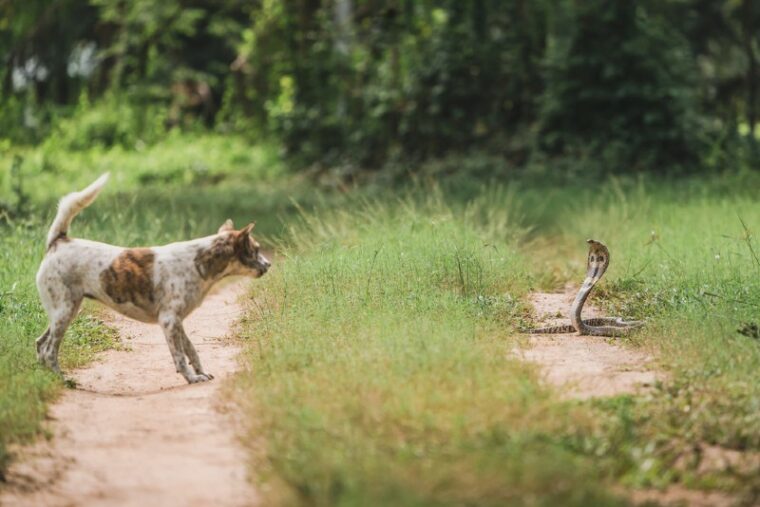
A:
36;173;271;384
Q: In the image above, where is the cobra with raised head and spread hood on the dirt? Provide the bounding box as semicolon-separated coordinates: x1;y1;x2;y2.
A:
527;239;644;336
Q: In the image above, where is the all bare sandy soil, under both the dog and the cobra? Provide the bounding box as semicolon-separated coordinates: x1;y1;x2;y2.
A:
0;281;744;507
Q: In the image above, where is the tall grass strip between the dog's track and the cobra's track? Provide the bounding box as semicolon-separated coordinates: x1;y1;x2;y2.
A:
240;198;636;505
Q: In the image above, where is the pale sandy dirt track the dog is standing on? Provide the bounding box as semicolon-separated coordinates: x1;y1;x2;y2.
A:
0;281;256;507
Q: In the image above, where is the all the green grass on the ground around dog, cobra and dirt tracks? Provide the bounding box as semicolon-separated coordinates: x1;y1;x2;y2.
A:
0;135;760;505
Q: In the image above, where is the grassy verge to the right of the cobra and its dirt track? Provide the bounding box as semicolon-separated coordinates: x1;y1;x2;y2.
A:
536;175;760;503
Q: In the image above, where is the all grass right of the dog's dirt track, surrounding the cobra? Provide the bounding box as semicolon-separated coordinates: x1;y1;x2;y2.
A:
240;174;760;505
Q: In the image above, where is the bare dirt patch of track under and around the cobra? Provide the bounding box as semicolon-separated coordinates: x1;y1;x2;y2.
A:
513;290;656;398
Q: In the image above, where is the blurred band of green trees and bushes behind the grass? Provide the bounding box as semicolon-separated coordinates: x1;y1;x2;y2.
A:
0;0;760;185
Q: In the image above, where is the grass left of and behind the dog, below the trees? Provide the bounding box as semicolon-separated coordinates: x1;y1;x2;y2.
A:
0;131;310;477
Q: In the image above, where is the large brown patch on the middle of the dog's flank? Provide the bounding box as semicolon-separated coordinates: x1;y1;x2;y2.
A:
100;248;156;310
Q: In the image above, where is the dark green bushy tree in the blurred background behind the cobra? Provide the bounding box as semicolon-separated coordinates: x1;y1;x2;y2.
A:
540;0;702;172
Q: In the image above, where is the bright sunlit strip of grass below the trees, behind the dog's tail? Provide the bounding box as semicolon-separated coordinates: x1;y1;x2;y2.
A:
0;133;287;206
